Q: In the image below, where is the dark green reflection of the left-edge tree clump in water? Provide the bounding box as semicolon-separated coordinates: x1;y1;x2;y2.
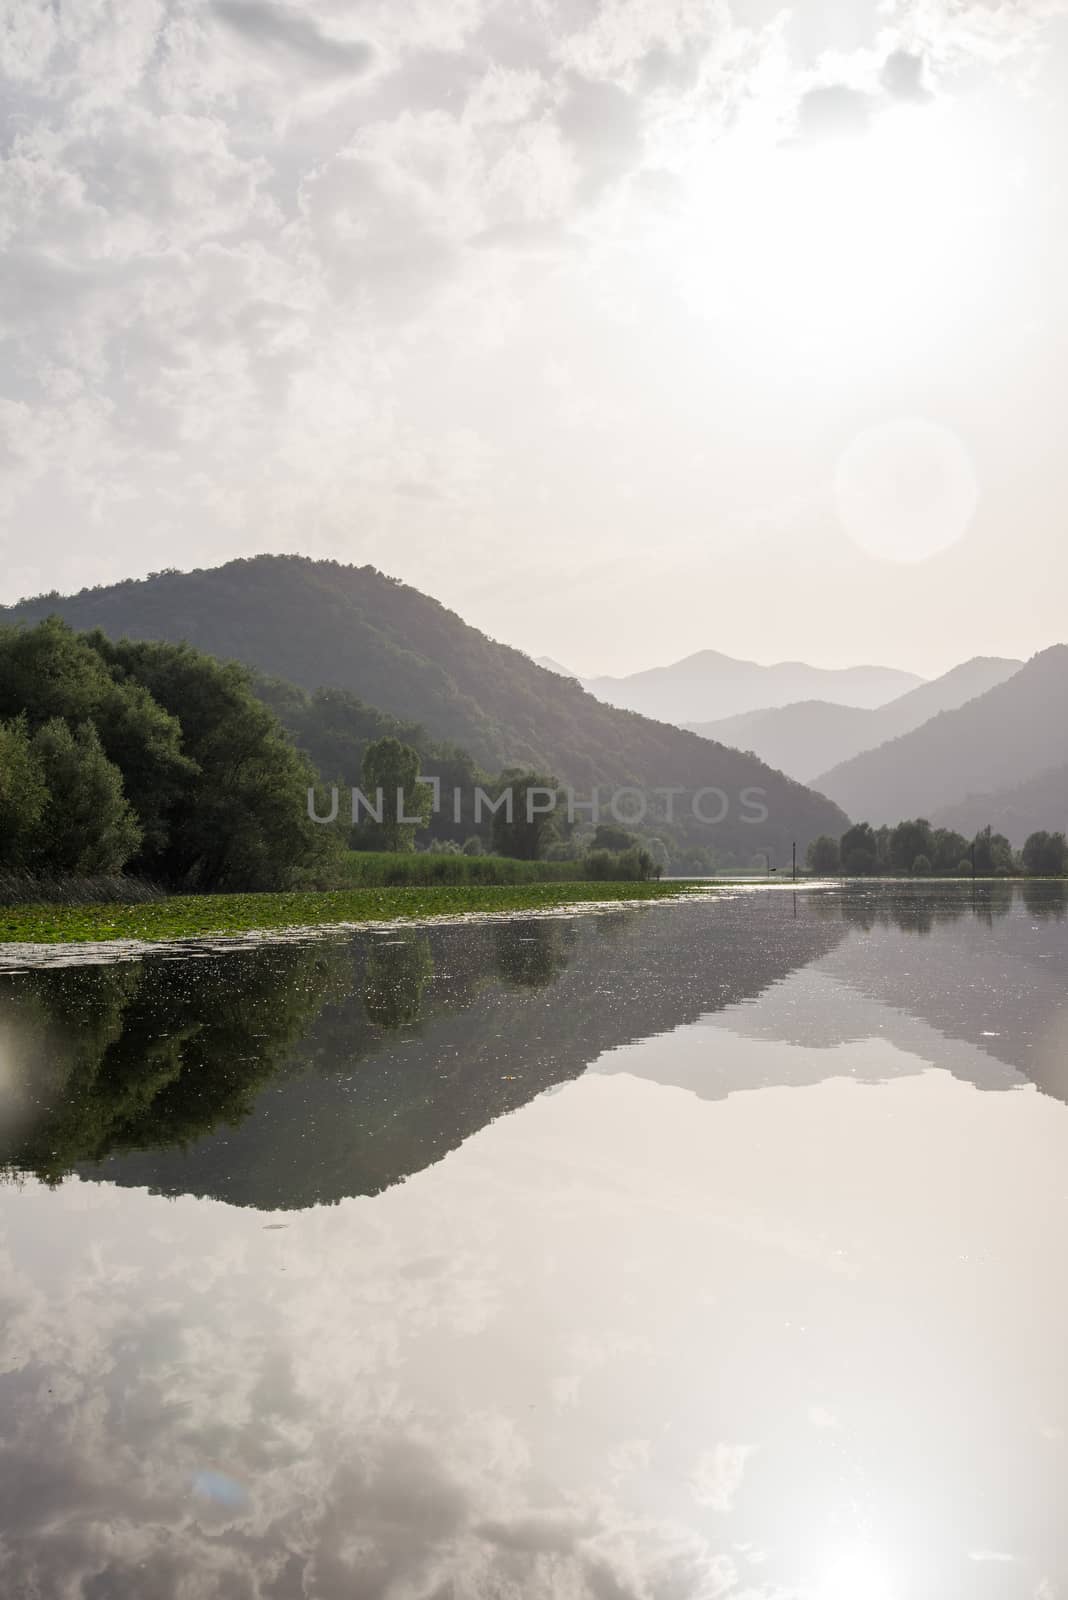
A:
0;946;341;1182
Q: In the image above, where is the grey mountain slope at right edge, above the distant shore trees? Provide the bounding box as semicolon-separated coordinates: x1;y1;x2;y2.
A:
817;645;1068;822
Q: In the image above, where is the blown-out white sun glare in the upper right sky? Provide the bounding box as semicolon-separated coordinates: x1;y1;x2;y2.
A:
664;95;983;365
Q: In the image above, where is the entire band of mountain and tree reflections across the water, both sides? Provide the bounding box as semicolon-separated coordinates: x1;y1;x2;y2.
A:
0;885;1068;1208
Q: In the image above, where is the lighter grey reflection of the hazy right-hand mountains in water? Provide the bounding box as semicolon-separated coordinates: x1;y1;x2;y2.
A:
600;883;1068;1101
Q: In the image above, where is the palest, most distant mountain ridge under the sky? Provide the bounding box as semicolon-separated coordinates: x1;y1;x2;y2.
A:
584;650;923;723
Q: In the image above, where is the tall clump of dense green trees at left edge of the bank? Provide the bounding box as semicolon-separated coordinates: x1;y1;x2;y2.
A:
0;618;339;890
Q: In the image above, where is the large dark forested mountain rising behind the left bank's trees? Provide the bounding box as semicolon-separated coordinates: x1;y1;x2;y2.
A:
0;555;846;861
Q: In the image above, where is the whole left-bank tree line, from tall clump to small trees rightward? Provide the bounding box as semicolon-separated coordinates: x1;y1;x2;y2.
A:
0;618;662;893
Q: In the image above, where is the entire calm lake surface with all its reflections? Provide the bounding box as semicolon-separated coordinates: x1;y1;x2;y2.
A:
0;886;1068;1600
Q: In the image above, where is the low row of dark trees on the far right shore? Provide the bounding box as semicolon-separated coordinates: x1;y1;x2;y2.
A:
806;818;1068;878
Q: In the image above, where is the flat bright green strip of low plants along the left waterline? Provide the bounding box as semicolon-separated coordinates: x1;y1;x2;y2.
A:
0;882;707;944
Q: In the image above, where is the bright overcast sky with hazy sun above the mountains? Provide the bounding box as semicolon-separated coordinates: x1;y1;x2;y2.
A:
0;0;1068;674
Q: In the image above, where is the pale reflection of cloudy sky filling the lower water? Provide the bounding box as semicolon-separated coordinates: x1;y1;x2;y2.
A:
0;1029;1068;1600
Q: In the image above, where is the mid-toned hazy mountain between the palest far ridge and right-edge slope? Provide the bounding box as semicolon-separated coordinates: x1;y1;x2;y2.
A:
689;656;1023;782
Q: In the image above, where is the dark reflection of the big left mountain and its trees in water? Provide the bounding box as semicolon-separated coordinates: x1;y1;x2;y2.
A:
0;898;846;1208
